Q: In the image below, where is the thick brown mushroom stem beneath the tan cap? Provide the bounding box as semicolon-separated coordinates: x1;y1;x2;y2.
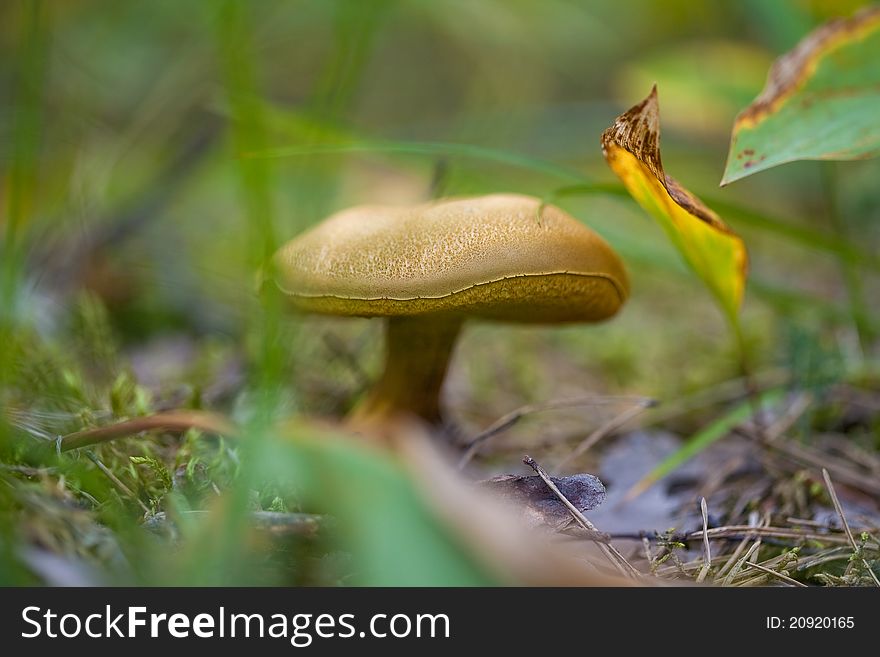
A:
349;315;462;426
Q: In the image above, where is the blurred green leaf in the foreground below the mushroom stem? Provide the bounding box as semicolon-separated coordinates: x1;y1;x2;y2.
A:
260;426;499;586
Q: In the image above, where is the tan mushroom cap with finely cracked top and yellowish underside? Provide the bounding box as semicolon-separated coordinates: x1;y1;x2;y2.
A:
274;194;629;323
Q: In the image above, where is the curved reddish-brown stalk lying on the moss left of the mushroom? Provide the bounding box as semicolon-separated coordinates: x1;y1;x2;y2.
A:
60;411;238;452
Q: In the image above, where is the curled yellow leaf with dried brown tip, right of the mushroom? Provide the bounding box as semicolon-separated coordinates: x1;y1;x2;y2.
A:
602;85;748;325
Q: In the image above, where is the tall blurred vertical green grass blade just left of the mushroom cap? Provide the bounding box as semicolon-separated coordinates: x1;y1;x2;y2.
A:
174;0;285;585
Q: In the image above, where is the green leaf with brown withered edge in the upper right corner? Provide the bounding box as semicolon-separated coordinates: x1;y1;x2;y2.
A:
721;6;880;185
